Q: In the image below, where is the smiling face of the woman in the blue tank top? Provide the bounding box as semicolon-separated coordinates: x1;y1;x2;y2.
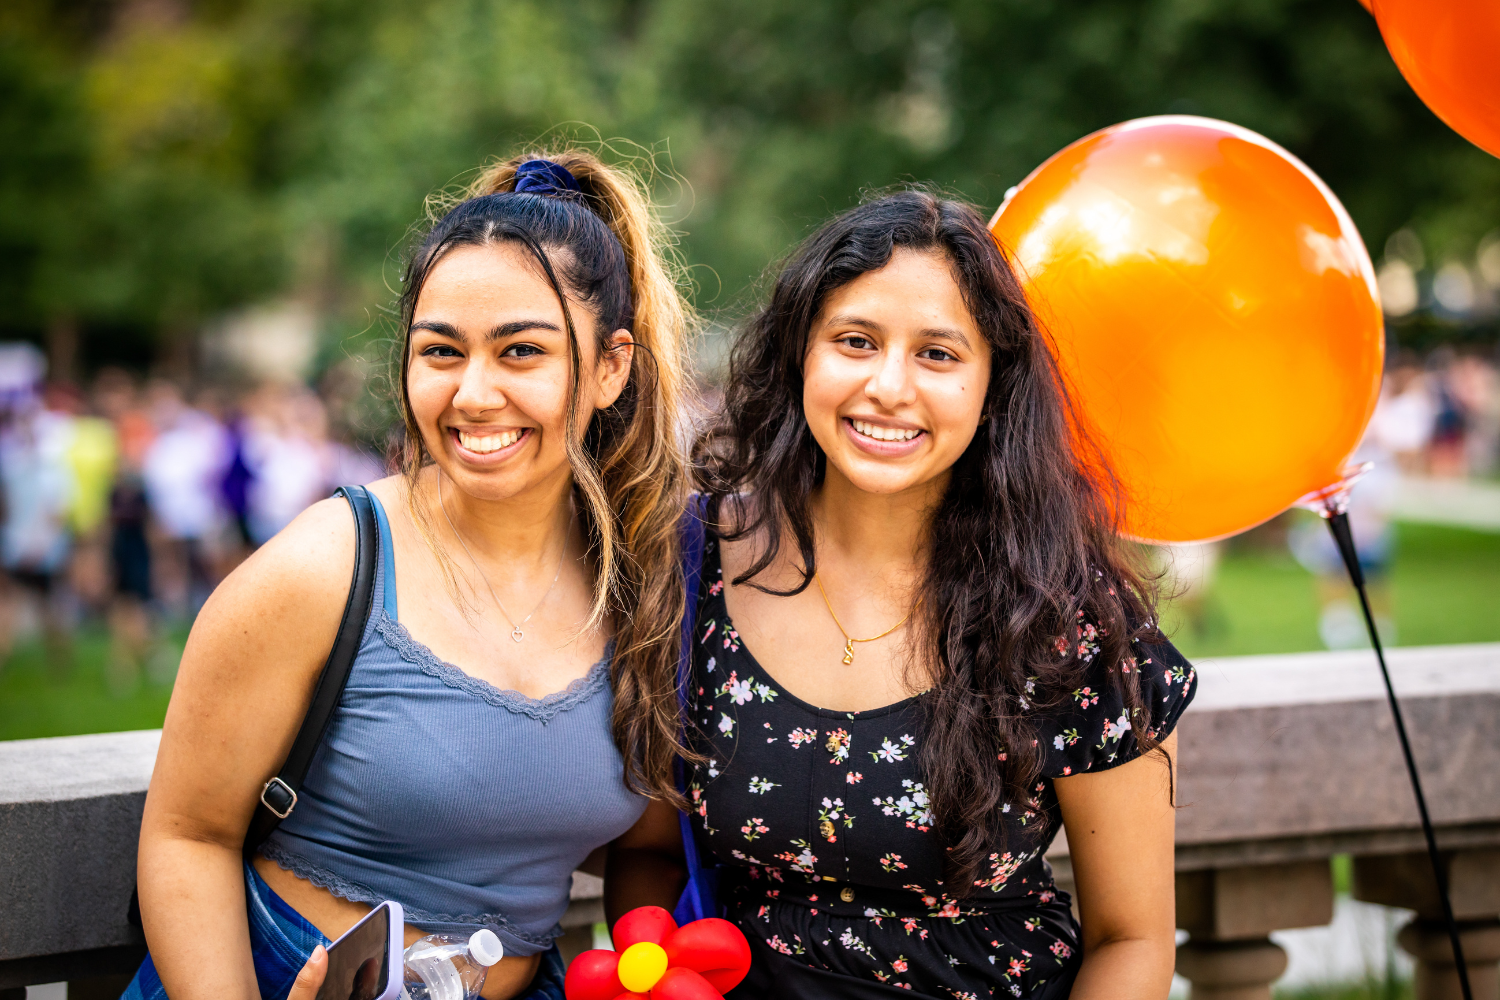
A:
407;243;632;499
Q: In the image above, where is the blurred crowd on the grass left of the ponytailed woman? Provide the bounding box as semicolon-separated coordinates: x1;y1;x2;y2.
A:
0;343;383;690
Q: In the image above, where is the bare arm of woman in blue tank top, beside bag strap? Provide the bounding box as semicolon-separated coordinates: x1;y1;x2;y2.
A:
137;499;354;1000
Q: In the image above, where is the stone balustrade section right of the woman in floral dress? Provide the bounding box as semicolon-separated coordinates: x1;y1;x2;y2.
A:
1152;643;1500;1000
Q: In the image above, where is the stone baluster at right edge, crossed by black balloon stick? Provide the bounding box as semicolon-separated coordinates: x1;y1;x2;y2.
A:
1353;849;1500;1000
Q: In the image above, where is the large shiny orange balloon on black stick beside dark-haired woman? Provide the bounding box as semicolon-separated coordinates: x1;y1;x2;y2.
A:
992;115;1385;541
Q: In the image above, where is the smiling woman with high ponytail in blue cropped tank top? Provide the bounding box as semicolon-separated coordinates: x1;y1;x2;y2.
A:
126;148;687;1000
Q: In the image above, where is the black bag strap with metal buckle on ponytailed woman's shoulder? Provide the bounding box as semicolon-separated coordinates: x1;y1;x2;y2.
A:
245;486;380;855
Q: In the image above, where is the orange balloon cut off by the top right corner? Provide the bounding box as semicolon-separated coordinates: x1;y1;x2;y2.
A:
1373;0;1500;156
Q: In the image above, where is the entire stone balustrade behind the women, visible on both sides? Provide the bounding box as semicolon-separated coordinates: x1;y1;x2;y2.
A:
0;643;1500;1000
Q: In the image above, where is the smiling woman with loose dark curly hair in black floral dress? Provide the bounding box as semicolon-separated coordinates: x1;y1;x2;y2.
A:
621;190;1194;1000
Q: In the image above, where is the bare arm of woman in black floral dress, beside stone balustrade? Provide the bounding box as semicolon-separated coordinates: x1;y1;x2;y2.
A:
1055;733;1178;1000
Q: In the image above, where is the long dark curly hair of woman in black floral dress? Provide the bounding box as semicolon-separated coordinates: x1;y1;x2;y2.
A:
693;190;1160;895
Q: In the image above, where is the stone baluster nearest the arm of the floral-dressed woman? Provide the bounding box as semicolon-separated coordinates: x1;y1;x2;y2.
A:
1178;859;1334;1000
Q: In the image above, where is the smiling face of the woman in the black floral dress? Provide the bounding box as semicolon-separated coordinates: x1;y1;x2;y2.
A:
803;250;990;495
